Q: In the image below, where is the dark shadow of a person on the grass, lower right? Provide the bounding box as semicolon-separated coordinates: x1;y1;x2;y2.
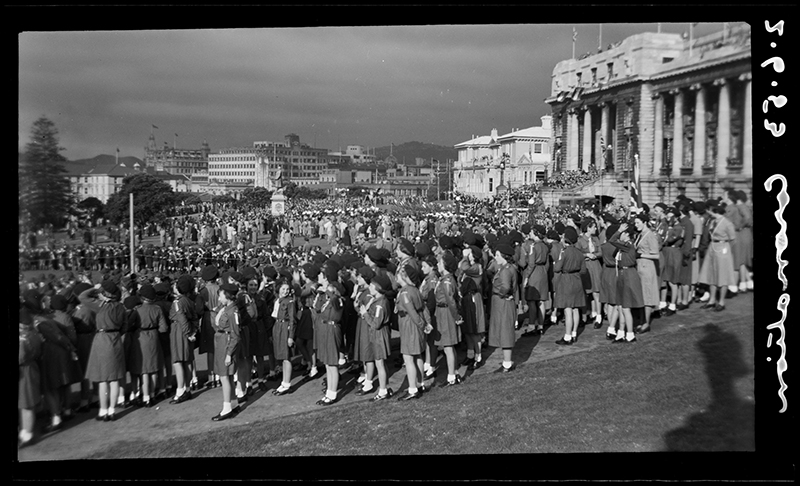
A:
664;323;755;451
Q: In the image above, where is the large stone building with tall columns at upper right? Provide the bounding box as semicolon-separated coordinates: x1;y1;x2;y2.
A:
545;24;753;205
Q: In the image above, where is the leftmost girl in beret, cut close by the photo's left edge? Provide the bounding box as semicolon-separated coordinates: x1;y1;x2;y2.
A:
17;308;43;447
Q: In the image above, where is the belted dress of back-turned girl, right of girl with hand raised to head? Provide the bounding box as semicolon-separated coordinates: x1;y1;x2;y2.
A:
128;302;168;375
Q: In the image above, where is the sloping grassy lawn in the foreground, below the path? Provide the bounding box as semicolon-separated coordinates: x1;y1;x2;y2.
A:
94;315;755;460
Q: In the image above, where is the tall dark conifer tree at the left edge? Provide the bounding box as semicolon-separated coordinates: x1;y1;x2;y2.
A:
19;116;72;230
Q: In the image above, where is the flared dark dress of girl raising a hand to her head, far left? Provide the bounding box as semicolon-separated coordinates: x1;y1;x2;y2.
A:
86;301;127;383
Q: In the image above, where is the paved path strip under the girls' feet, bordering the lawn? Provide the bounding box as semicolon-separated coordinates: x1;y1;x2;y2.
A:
18;293;754;462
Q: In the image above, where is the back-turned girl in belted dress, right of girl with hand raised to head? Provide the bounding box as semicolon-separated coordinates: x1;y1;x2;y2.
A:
128;284;168;408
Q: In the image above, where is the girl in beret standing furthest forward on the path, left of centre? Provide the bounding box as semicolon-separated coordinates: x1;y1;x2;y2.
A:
211;283;240;422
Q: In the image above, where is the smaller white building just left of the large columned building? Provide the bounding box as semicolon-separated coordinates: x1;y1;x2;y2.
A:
453;115;552;198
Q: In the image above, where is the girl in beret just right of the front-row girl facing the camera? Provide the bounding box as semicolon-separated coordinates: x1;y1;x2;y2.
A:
312;272;343;406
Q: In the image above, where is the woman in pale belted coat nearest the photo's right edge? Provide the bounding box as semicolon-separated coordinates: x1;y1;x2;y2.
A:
699;202;737;312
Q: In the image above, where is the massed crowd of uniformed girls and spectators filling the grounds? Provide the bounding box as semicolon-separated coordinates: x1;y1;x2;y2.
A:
18;186;753;446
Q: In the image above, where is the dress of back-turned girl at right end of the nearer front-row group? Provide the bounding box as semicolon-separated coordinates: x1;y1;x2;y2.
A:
489;257;520;348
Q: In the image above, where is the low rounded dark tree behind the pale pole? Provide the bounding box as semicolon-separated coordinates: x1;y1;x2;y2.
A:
105;174;178;225
